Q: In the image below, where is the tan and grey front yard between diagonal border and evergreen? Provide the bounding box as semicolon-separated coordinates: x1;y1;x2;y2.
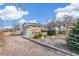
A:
29;34;78;53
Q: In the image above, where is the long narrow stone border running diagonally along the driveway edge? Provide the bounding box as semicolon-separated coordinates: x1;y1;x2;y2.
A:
22;36;78;56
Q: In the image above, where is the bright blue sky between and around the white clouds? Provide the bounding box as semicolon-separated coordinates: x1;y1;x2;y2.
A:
0;3;69;26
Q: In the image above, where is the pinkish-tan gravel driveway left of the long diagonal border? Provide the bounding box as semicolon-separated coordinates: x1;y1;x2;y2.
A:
0;36;62;56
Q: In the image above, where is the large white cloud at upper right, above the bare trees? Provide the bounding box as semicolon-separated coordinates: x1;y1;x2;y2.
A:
55;3;79;19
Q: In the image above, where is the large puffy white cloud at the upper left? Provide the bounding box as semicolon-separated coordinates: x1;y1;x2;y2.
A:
0;6;28;20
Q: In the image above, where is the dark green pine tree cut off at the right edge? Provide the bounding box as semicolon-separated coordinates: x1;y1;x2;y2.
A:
67;19;79;53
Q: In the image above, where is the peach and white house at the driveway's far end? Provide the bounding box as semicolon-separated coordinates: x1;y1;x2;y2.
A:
22;23;47;37
